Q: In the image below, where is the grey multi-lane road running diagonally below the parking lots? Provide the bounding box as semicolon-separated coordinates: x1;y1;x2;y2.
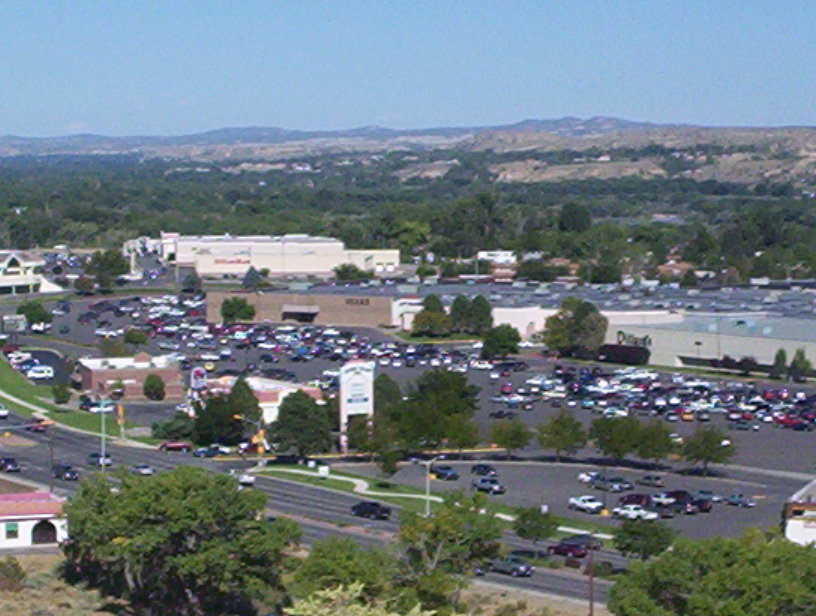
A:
0;414;608;603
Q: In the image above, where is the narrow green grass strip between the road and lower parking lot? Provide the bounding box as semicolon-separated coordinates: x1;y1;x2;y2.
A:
261;466;614;537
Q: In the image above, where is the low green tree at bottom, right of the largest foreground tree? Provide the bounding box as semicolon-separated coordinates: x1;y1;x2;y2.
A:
292;537;398;603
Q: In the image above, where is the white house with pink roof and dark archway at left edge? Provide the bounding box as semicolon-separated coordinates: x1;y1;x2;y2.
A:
0;492;68;550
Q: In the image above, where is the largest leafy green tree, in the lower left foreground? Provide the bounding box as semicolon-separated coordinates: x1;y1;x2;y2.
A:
63;466;300;616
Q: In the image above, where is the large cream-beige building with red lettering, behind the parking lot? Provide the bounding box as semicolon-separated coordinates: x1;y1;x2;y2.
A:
124;232;400;276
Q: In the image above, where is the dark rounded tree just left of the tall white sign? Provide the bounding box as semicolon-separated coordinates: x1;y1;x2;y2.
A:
270;391;332;458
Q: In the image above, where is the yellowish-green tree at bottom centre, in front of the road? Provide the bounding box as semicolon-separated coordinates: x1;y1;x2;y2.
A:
397;492;502;608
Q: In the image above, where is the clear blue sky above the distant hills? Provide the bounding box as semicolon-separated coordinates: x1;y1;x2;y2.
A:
0;0;816;136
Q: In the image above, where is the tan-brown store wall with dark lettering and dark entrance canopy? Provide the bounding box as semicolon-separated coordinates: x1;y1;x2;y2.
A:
207;291;393;327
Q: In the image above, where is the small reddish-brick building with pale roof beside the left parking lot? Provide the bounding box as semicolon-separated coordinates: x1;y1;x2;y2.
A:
78;353;185;400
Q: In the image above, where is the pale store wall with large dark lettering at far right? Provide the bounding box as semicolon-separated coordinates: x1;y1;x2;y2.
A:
606;324;816;367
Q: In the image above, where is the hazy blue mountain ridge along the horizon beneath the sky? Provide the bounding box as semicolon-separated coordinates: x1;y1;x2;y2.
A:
0;117;659;156
